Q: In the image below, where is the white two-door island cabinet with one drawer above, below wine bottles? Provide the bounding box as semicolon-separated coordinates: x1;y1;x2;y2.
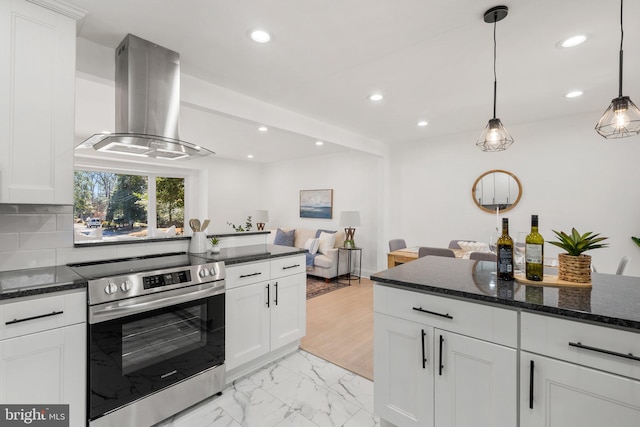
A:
374;285;518;427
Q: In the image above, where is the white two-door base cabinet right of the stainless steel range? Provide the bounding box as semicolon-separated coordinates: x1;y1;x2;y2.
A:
225;255;306;380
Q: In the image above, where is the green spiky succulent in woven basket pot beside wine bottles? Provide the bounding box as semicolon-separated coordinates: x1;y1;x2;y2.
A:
549;228;609;283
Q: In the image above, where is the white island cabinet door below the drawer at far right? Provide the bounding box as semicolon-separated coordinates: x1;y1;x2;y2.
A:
520;352;640;427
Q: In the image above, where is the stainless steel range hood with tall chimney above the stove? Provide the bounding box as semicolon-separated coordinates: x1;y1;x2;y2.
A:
76;34;215;160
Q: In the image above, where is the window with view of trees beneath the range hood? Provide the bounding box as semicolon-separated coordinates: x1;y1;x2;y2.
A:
73;167;190;244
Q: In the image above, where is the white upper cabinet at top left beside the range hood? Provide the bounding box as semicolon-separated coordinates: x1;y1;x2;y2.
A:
0;0;83;204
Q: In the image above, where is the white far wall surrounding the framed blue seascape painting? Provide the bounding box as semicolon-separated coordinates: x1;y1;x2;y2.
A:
262;151;386;276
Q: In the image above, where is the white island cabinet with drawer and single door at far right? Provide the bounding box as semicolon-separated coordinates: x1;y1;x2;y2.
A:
520;312;640;427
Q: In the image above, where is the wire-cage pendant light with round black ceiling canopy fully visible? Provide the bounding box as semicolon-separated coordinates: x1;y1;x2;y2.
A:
476;6;513;151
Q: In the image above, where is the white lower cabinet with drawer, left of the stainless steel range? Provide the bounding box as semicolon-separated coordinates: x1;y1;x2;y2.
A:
0;291;87;427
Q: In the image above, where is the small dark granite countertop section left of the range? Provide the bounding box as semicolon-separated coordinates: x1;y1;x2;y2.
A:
0;265;87;300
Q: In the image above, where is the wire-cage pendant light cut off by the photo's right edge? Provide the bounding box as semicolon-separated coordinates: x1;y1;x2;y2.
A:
596;0;640;139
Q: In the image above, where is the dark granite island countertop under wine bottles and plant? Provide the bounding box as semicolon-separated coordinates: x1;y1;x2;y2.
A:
371;256;640;332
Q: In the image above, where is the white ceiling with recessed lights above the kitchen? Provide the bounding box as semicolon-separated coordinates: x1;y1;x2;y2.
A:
68;0;640;162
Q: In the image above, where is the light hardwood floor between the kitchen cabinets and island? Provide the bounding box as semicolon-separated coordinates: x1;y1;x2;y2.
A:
301;278;373;380
